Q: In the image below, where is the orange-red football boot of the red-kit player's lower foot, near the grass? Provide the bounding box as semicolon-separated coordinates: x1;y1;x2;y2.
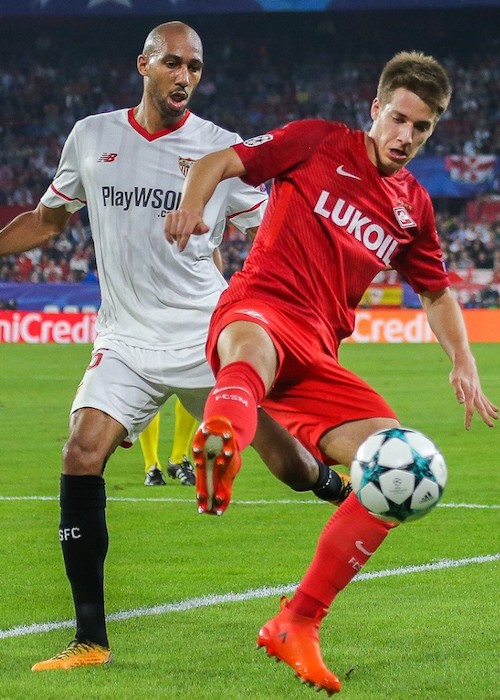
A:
257;596;341;696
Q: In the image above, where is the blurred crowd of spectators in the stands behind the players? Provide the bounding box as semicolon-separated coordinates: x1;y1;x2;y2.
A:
0;15;500;306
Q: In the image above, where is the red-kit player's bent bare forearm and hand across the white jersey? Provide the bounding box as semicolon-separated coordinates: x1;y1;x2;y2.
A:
165;148;246;251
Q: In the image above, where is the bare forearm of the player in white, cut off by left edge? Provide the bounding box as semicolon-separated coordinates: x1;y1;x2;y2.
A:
0;202;71;255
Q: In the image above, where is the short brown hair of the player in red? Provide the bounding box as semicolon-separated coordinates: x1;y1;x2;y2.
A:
377;51;451;117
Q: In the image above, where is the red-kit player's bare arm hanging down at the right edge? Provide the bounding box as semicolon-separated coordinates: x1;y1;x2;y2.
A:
420;289;498;430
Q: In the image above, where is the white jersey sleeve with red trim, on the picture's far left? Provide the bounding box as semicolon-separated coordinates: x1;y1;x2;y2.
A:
41;124;87;213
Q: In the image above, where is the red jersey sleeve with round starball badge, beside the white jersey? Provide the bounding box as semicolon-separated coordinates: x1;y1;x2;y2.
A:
232;119;332;186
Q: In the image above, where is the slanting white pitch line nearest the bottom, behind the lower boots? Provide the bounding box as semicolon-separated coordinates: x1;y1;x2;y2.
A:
0;552;500;639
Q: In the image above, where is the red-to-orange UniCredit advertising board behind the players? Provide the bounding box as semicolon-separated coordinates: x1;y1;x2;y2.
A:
0;309;500;344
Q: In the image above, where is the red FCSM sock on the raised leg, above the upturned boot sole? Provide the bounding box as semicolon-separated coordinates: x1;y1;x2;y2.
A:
203;361;266;450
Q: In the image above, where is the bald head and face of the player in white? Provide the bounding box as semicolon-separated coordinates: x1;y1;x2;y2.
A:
138;32;203;123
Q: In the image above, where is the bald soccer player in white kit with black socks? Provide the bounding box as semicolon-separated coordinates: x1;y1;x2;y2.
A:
0;22;350;671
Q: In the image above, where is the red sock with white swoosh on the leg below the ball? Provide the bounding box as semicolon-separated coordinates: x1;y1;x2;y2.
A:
289;494;394;617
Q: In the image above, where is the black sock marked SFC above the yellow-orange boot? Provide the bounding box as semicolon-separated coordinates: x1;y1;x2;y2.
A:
59;474;108;647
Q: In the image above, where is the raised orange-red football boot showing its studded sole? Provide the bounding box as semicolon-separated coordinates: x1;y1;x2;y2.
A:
193;416;241;515
